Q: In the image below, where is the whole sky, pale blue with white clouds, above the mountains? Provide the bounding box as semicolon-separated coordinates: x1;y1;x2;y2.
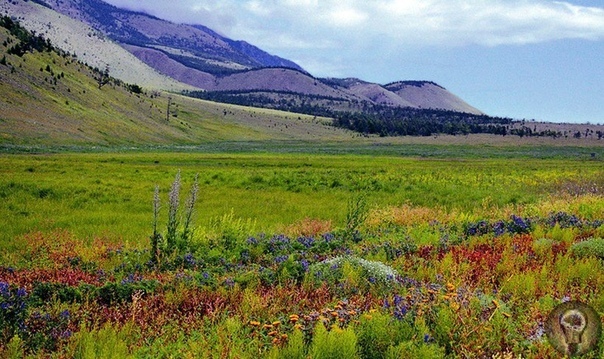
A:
105;0;604;124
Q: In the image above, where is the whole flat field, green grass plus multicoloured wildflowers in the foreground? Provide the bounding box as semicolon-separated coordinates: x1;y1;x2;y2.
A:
0;149;604;358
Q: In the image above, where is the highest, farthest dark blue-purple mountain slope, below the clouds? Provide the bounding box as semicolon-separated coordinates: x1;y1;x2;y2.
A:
34;0;302;74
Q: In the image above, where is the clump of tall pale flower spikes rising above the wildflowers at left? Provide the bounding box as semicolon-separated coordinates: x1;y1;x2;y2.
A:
151;170;199;263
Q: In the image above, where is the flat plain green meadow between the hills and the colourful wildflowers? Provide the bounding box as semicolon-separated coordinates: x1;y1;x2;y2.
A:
0;152;604;245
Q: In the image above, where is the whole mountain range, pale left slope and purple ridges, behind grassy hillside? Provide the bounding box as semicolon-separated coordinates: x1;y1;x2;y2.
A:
0;0;482;115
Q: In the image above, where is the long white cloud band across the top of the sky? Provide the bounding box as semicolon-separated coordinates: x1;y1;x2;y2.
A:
108;0;604;48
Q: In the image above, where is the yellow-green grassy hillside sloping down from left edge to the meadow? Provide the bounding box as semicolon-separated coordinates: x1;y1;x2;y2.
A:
0;25;358;145
